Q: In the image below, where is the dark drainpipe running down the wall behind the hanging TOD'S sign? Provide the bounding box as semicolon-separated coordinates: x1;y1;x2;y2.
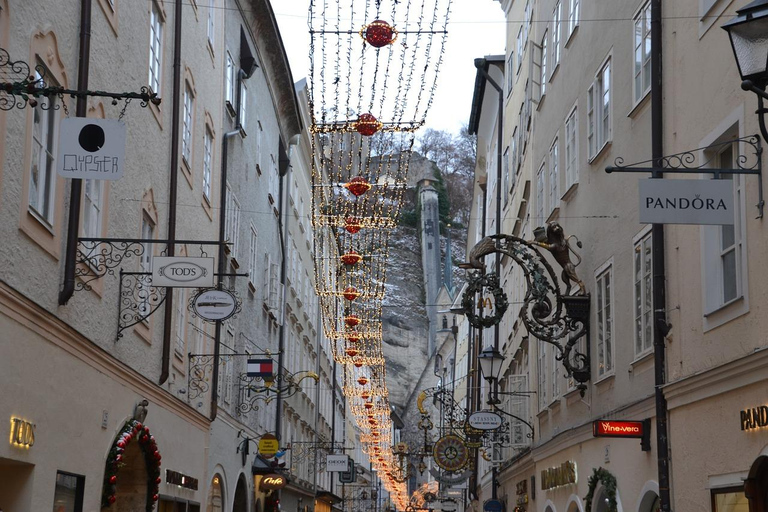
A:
158;2;183;384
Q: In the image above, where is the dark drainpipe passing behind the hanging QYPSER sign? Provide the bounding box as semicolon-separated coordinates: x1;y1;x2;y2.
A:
59;0;92;306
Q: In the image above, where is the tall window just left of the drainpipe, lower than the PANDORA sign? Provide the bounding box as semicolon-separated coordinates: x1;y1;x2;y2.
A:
633;231;653;356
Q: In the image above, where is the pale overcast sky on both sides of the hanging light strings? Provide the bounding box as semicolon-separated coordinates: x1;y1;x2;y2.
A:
272;0;504;133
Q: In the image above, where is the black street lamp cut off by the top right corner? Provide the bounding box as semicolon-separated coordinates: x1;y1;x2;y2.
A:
723;0;768;140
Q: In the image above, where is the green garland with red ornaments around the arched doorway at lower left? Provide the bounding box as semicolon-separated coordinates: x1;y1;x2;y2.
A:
101;419;162;512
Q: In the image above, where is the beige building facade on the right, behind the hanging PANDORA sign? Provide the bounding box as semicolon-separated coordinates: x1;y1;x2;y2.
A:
468;0;768;512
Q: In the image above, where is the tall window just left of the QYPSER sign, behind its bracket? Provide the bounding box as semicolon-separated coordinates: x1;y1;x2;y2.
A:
29;68;58;228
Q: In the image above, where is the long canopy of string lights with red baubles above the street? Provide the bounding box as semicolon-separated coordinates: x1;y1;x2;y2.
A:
309;0;451;504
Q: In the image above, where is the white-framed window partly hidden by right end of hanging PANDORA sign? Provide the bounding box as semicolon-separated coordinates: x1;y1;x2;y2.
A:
702;143;747;313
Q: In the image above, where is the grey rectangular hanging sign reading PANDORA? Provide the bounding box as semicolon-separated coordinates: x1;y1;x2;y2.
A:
638;179;735;225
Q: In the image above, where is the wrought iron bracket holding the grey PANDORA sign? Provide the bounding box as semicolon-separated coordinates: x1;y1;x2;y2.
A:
605;134;765;219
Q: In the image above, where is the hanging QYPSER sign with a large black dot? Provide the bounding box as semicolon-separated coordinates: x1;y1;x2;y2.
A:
56;117;125;180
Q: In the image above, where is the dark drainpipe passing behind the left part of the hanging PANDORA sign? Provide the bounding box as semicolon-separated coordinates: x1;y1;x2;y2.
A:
651;0;672;512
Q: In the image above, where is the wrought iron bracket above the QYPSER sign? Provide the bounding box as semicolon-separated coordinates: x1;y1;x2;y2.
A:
0;48;161;111
